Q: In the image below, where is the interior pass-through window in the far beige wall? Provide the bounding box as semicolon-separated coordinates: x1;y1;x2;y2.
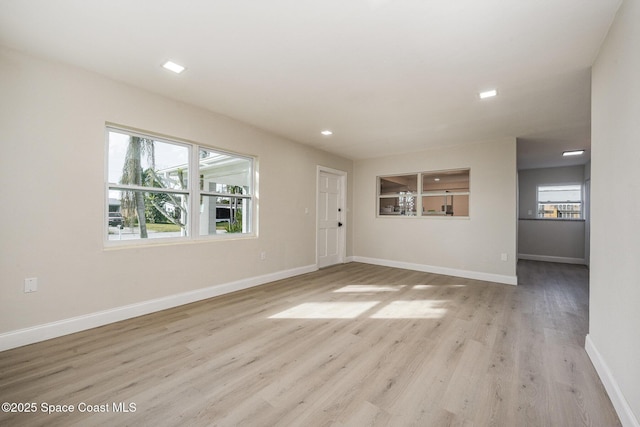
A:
378;169;470;217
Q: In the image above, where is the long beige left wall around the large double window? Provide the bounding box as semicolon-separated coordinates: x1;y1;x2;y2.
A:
0;50;353;334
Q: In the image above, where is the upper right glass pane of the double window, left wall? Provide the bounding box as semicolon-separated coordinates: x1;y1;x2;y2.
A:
199;149;253;195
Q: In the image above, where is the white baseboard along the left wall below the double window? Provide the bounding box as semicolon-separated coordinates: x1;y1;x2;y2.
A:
0;265;318;351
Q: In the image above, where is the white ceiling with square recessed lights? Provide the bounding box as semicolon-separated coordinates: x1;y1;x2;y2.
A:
0;0;621;168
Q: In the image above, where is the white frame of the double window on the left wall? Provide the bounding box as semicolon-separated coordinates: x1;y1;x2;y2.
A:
103;124;258;247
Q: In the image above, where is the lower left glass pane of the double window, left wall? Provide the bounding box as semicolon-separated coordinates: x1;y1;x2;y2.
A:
106;190;189;240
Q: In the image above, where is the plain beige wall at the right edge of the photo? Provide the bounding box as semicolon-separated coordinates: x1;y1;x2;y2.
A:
587;0;640;426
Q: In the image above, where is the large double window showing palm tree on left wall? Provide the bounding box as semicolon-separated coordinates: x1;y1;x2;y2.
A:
105;127;255;241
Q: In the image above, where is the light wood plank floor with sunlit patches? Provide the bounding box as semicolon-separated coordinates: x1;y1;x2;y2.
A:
0;261;619;427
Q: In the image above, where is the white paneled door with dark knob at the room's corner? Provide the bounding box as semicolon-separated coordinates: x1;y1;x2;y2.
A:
316;169;346;268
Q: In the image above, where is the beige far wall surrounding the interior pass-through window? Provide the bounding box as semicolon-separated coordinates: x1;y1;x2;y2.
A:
353;139;516;279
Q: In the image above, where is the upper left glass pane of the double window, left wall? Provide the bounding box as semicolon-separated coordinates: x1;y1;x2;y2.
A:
108;130;189;190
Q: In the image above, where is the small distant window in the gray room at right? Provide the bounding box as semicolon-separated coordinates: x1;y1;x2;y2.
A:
538;184;582;219
